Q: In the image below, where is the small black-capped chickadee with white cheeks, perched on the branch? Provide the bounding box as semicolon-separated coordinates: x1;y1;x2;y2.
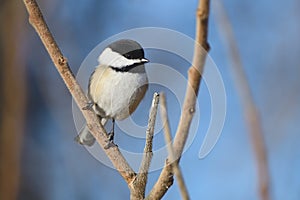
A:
75;39;149;147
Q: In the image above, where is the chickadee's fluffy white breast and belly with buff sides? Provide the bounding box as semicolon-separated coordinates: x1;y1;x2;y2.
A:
89;67;148;120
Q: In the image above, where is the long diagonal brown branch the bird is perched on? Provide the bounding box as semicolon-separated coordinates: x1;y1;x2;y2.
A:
24;0;136;184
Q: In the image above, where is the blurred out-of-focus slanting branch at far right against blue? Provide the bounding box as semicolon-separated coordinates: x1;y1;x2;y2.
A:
214;1;270;200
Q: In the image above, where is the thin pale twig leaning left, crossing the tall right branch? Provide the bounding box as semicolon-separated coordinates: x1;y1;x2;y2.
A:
160;93;190;200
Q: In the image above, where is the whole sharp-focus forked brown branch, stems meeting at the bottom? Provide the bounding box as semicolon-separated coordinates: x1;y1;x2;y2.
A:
23;0;210;200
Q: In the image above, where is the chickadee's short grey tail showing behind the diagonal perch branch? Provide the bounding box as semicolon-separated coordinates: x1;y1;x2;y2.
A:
74;118;107;146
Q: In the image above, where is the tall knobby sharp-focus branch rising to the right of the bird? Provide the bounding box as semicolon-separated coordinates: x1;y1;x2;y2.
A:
146;0;210;199
